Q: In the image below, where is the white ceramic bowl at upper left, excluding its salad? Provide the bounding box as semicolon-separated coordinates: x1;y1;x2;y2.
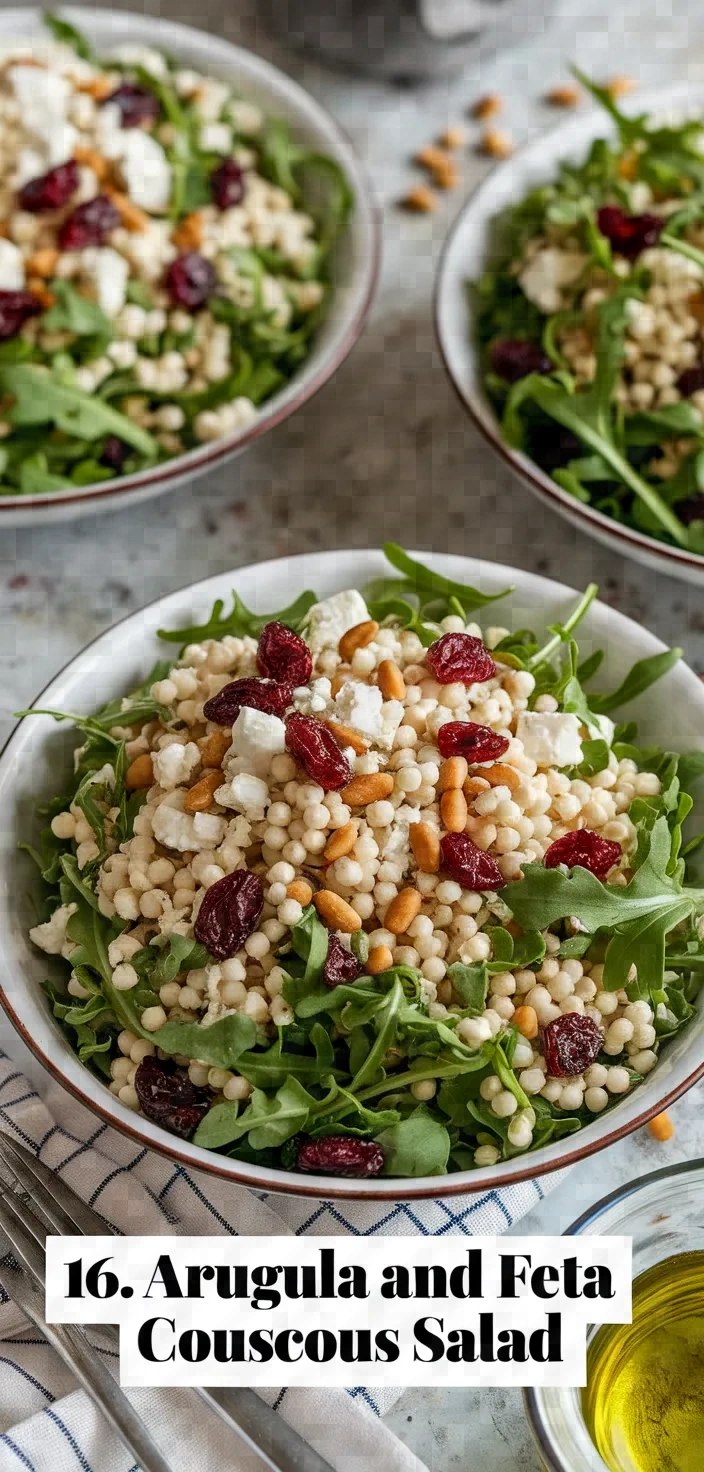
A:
0;6;380;530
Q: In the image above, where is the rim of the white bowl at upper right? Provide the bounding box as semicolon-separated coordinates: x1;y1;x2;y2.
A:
433;82;704;576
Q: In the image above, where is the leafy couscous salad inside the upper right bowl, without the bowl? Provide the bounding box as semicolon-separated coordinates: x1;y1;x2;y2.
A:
473;67;704;555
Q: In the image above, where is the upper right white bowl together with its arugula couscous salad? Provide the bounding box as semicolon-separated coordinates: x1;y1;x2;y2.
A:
437;78;704;581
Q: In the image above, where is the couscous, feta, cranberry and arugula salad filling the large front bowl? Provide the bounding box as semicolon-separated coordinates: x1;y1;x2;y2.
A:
22;545;704;1176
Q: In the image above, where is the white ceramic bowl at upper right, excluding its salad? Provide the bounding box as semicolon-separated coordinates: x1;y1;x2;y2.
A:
434;84;704;587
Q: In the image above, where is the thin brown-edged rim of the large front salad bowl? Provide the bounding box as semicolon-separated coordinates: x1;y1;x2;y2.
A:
0;548;704;1203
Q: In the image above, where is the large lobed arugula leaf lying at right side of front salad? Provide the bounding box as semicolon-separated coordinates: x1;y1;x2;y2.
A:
501;814;704;997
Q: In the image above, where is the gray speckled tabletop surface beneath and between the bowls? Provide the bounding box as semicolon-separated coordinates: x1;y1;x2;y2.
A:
0;0;704;1472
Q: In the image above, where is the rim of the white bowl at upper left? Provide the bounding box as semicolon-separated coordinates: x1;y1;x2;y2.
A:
0;6;381;518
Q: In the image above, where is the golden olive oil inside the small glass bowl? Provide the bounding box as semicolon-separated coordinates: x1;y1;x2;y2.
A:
582;1251;704;1472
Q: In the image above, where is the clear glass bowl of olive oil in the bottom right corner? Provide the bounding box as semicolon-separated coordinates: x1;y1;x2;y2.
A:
524;1160;704;1472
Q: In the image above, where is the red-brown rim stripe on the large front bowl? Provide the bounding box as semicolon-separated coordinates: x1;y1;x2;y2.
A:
0;548;704;1201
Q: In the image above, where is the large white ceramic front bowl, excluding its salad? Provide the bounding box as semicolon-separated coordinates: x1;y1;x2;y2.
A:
0;551;704;1200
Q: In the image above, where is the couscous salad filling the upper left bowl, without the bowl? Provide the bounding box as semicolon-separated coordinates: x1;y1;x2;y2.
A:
0;16;352;495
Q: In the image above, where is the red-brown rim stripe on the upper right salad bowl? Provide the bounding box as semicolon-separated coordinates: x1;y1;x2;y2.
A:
433;138;704;580
